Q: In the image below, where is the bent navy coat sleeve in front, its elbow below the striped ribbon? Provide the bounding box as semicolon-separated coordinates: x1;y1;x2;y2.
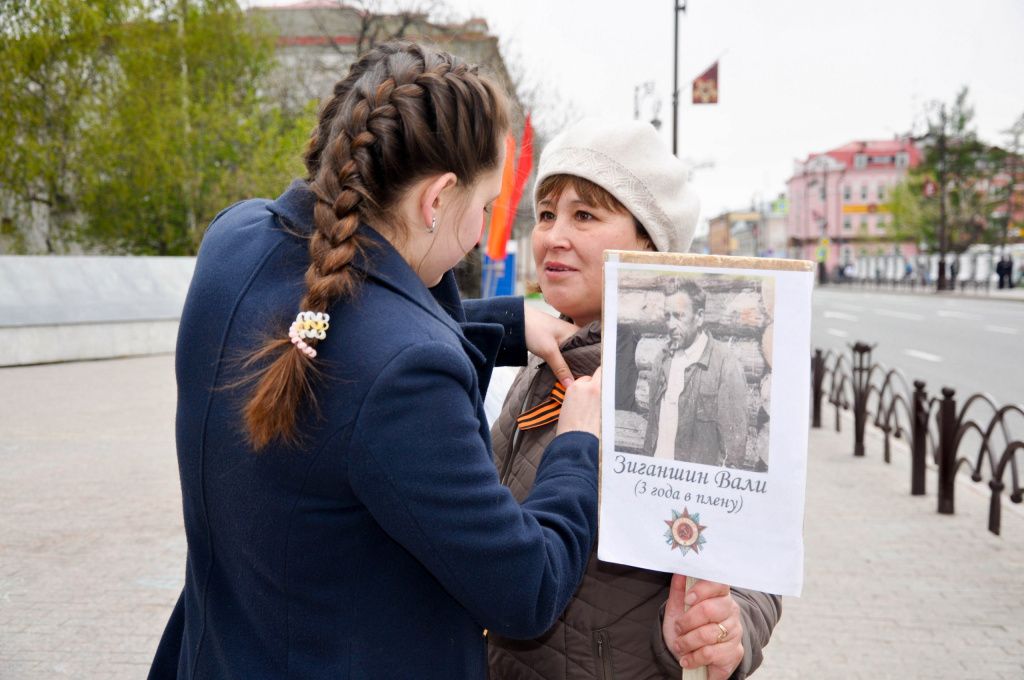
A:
349;342;597;639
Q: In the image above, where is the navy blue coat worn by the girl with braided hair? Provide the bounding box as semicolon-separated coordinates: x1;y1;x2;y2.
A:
151;182;597;680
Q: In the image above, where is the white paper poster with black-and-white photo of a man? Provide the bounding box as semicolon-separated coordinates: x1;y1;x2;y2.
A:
598;251;813;595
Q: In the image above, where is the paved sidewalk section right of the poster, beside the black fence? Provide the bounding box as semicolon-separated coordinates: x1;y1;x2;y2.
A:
755;421;1024;680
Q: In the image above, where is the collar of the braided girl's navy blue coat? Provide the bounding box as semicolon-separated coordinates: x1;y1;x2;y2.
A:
267;179;493;374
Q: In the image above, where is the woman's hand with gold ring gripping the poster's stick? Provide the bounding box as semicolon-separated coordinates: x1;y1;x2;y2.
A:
662;573;743;680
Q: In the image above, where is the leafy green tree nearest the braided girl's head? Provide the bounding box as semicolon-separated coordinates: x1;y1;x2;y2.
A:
80;0;313;255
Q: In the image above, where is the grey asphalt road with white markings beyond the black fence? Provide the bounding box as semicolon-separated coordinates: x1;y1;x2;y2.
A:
811;288;1024;403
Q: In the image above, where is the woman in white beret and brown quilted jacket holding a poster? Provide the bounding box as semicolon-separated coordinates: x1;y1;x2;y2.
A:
489;120;781;680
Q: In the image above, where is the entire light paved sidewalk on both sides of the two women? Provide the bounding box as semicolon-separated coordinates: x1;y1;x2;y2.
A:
0;356;1024;680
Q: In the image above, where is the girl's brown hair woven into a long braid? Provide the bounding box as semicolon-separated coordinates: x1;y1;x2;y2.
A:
244;42;509;450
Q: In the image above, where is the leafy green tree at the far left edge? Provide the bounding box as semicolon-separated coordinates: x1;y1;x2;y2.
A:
0;0;137;253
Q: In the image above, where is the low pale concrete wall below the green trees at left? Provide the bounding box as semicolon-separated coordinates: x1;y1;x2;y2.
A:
0;256;196;366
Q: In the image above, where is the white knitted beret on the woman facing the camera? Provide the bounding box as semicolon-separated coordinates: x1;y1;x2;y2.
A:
534;118;700;253
